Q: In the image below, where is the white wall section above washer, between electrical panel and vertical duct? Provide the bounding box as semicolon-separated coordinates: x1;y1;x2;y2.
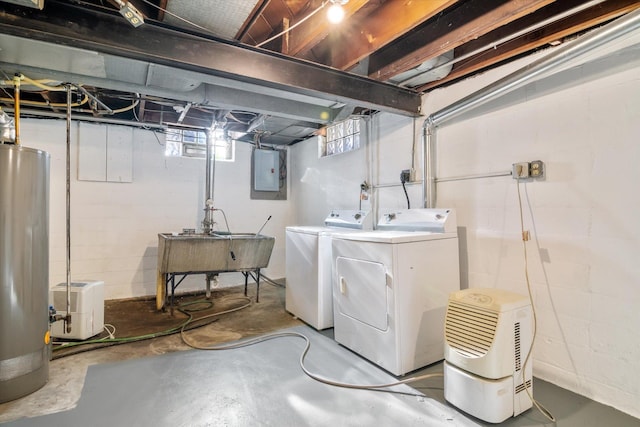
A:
289;114;422;225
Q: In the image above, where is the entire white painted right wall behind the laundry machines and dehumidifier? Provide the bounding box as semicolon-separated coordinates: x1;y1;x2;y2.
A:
291;41;640;417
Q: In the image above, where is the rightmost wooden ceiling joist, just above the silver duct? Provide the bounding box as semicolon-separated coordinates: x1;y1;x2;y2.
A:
418;0;640;92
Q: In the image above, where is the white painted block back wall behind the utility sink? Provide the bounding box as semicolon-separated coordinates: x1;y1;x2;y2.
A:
21;120;290;299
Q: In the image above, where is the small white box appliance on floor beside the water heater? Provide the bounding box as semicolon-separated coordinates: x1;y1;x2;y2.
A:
49;280;104;340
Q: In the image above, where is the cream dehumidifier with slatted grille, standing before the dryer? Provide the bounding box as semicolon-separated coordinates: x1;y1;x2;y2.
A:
444;288;533;423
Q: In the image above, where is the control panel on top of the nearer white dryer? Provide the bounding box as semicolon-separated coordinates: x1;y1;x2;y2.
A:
376;209;457;233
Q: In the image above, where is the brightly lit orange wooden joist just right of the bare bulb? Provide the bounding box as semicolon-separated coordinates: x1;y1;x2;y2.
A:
306;0;459;70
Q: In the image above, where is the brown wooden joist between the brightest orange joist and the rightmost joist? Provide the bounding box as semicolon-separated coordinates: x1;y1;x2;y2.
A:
369;0;553;81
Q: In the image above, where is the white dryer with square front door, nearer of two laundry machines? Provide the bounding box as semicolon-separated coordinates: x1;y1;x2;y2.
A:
331;209;460;375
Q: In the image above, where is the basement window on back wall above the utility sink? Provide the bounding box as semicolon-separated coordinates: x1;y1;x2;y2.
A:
164;128;235;162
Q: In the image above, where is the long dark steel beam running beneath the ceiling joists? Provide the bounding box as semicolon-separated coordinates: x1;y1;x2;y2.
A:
0;1;421;116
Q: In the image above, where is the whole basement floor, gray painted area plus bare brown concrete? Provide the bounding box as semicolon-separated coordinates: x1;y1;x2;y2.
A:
0;287;640;427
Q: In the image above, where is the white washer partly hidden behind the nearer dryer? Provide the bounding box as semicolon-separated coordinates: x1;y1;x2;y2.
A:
285;209;373;330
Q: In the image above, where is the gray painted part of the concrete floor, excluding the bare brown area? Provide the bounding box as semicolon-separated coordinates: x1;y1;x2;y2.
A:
2;326;640;427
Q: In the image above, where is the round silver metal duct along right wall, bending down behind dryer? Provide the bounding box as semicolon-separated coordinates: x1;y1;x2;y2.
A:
422;9;640;208
